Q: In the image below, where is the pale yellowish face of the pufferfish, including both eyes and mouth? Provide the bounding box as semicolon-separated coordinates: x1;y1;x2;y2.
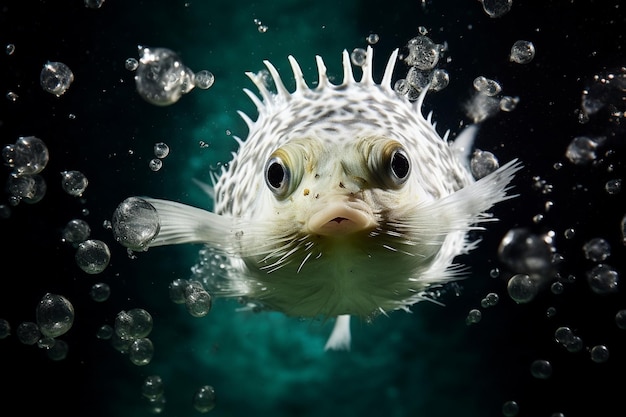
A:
264;135;416;238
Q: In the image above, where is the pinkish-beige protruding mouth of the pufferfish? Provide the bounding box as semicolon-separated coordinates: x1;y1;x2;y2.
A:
308;201;377;236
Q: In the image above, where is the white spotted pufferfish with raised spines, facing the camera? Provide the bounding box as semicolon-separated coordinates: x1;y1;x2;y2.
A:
111;47;520;349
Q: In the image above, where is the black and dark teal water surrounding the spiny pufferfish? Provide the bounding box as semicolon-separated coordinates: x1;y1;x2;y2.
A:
0;0;626;417
